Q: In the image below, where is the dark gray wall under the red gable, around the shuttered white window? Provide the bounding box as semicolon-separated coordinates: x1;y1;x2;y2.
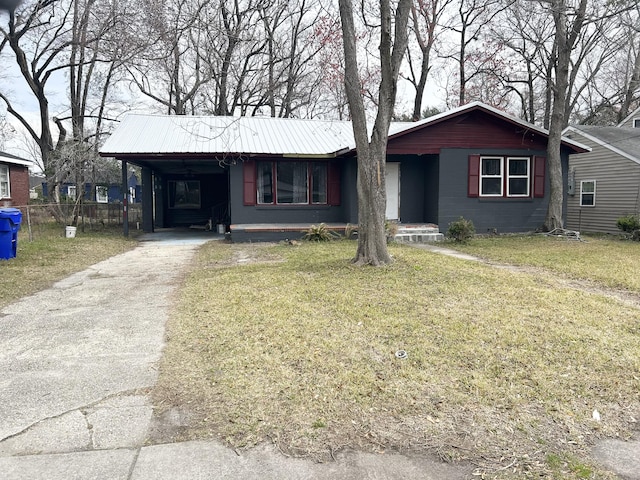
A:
438;148;567;234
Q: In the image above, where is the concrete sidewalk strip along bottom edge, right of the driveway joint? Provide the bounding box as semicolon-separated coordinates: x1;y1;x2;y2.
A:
132;442;471;480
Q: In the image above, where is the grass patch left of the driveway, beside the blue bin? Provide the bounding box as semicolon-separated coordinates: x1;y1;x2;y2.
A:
0;223;136;307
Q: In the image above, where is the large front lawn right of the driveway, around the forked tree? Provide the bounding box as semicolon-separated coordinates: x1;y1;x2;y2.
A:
154;239;640;479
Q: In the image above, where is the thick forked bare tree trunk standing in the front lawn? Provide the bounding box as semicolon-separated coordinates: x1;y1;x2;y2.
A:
339;0;411;265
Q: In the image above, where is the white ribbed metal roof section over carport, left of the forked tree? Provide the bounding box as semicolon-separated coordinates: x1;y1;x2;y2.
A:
100;115;353;156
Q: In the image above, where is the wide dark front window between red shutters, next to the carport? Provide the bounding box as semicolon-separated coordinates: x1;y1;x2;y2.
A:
256;162;328;205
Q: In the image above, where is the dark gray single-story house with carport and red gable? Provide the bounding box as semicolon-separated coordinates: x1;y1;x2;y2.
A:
100;102;588;241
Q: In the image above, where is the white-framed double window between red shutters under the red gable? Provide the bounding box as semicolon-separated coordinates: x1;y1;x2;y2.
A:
480;157;531;197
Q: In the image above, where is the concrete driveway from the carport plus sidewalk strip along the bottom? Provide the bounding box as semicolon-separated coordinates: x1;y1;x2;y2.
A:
0;232;472;480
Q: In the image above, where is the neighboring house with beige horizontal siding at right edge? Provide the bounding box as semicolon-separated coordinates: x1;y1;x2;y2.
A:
565;124;640;233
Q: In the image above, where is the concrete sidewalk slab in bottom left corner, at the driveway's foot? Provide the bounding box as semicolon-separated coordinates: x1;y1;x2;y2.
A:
0;450;137;480
